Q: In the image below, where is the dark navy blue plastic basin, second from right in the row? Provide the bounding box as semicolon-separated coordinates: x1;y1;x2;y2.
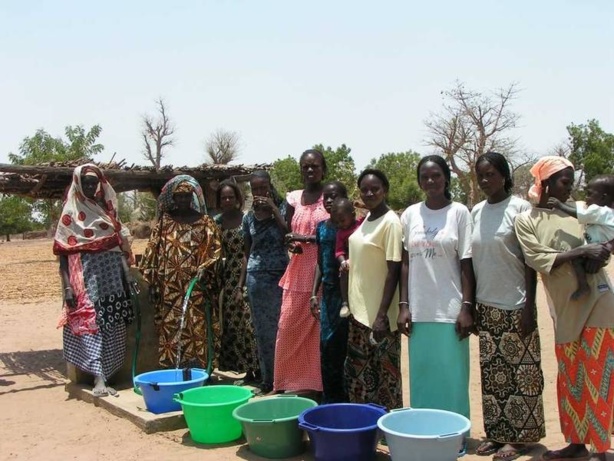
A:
298;403;386;461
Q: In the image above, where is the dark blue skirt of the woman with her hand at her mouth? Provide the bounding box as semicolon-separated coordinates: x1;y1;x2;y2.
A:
246;270;284;386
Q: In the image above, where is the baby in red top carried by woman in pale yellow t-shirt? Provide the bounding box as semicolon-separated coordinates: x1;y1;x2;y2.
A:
330;198;364;317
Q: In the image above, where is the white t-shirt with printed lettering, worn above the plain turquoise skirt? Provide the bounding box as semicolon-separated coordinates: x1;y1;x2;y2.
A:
401;202;472;323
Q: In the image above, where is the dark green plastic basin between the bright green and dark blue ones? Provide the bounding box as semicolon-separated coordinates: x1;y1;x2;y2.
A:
232;395;317;459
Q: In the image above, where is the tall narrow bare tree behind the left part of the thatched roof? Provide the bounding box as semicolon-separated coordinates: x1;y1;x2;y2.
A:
141;98;175;170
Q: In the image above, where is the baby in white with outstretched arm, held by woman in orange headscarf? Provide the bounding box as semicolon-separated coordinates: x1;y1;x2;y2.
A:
548;175;614;299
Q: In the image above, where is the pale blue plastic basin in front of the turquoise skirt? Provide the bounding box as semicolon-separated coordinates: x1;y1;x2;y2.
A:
377;408;471;461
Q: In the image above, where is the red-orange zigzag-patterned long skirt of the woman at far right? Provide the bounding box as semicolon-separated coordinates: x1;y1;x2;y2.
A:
555;327;614;453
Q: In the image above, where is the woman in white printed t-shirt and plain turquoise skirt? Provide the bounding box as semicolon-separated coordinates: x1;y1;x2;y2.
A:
397;155;475;417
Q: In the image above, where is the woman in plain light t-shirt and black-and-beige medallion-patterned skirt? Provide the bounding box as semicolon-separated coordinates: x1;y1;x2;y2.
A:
471;152;546;460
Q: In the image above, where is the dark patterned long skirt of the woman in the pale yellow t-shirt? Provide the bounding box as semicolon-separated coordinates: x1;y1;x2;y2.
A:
345;318;403;410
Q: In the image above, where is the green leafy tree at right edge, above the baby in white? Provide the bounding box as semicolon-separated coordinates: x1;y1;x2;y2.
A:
567;119;614;182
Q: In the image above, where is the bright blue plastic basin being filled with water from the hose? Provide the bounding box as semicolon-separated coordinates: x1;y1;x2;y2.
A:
134;368;209;414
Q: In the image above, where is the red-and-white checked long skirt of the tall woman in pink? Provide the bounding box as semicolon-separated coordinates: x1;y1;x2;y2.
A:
273;290;322;391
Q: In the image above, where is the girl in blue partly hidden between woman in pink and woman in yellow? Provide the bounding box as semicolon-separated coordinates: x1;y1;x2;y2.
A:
310;181;348;403
